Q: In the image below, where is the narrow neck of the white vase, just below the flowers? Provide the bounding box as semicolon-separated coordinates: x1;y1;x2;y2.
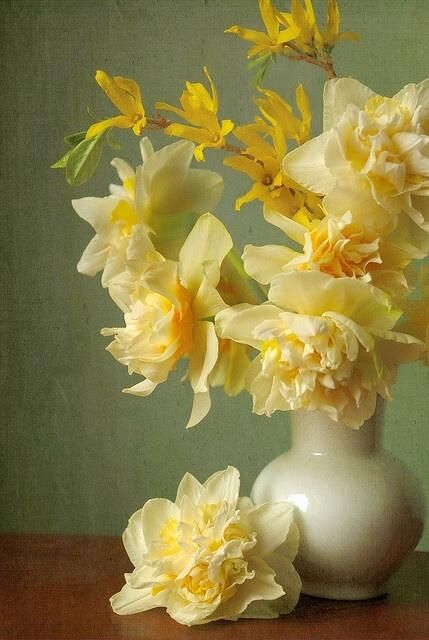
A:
291;407;382;455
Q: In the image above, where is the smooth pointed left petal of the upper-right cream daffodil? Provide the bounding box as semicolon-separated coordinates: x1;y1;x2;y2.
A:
282;131;335;194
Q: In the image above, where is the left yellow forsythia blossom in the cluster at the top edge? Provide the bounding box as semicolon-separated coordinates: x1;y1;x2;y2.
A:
225;0;300;58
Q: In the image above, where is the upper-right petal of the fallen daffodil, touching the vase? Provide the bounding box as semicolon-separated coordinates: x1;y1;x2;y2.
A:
247;502;293;558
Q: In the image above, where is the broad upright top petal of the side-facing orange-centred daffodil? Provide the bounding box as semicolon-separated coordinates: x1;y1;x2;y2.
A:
179;213;233;293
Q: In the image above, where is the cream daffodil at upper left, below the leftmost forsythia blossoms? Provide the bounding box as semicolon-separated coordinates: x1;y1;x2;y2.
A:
72;138;223;310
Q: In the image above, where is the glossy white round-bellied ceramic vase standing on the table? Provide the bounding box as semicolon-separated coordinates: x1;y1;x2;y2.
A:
251;407;425;600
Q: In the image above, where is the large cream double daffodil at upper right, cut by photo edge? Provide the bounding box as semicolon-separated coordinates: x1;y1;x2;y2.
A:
283;78;429;252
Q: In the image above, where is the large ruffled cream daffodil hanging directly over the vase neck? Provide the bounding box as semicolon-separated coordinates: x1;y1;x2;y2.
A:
216;271;422;428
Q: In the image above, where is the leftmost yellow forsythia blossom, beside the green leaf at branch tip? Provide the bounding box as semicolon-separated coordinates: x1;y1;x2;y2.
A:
86;71;146;139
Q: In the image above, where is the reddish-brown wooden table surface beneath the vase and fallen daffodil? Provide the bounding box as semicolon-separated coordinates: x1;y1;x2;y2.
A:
0;535;429;640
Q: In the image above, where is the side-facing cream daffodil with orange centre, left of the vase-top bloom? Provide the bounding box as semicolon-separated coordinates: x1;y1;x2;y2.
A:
102;213;232;427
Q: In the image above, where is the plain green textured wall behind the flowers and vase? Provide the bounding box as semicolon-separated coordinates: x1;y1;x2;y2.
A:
0;0;429;548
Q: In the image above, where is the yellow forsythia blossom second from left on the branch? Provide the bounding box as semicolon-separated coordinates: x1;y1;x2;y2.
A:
155;67;234;161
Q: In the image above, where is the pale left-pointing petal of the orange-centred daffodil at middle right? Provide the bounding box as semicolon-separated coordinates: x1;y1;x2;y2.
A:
242;244;300;284
